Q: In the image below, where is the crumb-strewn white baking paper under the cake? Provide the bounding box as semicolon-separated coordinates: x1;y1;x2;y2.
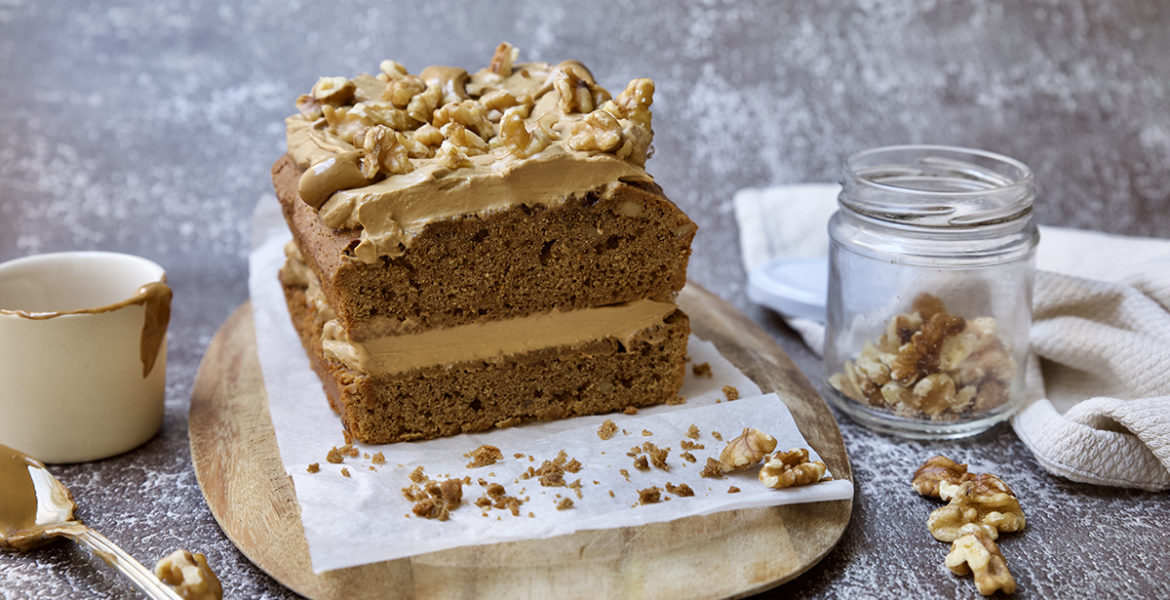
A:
249;196;853;573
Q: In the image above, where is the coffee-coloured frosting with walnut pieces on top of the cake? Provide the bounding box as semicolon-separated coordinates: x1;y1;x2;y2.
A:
285;42;654;262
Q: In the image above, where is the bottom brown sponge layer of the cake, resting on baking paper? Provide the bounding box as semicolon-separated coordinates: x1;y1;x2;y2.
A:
283;283;690;443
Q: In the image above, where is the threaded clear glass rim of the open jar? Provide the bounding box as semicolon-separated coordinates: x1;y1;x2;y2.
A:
839;144;1035;227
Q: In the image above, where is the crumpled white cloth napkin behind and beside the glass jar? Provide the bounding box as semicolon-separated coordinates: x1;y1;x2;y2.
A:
735;184;1170;490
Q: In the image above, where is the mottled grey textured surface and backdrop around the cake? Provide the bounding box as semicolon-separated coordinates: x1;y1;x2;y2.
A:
0;0;1170;600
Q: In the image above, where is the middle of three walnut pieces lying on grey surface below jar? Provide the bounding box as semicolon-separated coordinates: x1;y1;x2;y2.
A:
927;474;1025;542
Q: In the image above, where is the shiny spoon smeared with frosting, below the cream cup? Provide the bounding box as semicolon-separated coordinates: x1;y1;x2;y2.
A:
0;444;183;600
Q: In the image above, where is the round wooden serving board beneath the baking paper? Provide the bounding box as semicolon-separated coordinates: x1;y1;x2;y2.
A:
188;284;853;600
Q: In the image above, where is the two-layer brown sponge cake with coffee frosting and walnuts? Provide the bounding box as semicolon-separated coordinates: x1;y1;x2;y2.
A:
273;43;695;443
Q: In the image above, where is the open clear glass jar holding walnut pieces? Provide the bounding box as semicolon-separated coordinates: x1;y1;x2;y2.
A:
825;145;1039;439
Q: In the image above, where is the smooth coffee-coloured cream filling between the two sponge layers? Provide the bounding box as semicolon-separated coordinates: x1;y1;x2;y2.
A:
322;299;677;375
